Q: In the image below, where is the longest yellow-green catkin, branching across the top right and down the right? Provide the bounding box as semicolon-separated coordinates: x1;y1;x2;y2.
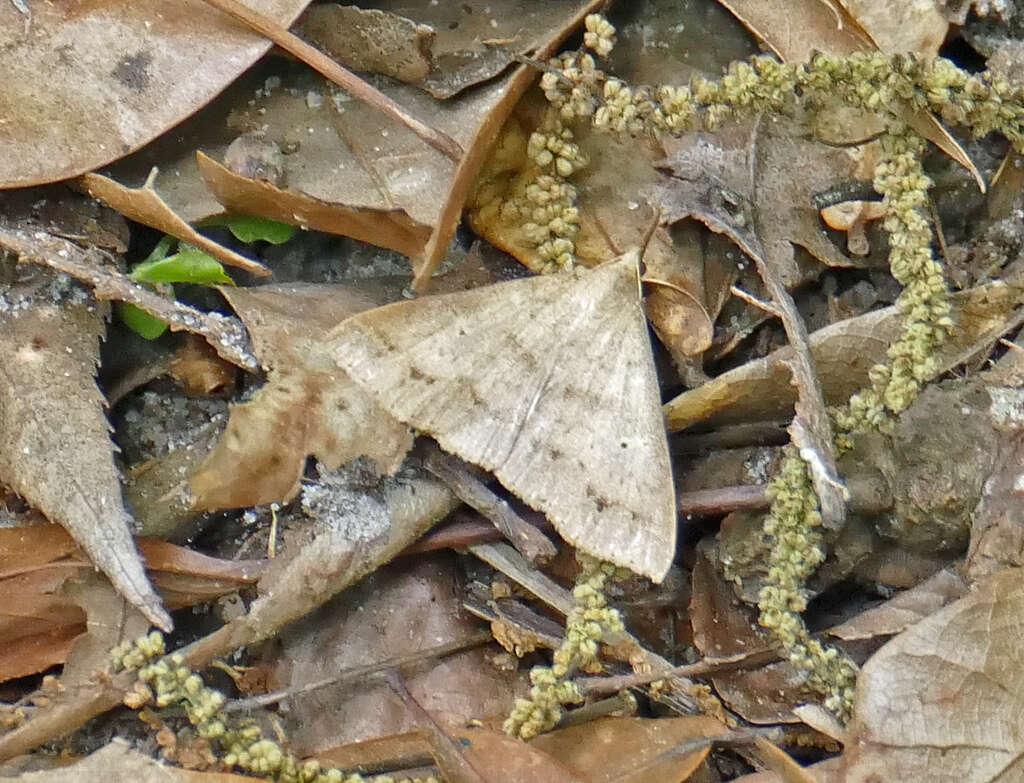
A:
535;14;1024;720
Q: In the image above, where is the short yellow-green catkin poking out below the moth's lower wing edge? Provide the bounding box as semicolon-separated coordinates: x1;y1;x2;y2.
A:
505;553;623;739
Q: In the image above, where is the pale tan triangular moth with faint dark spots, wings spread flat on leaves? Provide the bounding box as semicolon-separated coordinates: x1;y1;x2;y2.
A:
327;251;676;581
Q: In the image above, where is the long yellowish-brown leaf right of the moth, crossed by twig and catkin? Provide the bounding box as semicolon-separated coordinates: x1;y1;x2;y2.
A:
665;280;1024;432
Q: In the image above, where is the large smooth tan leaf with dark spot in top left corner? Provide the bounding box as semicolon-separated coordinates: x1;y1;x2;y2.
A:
0;0;307;187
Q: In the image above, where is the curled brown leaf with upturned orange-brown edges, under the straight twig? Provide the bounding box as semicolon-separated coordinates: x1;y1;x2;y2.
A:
182;0;594;288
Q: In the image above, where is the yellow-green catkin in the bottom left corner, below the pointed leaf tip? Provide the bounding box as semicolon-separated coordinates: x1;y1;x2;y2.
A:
112;632;439;783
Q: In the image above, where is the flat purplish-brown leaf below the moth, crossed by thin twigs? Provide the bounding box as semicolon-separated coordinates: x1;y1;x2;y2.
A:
271;554;529;755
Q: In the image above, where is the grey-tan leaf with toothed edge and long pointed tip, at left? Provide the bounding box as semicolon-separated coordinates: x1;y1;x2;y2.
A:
0;262;172;630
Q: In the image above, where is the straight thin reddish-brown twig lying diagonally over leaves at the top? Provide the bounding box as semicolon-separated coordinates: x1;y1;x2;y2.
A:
197;0;465;162
